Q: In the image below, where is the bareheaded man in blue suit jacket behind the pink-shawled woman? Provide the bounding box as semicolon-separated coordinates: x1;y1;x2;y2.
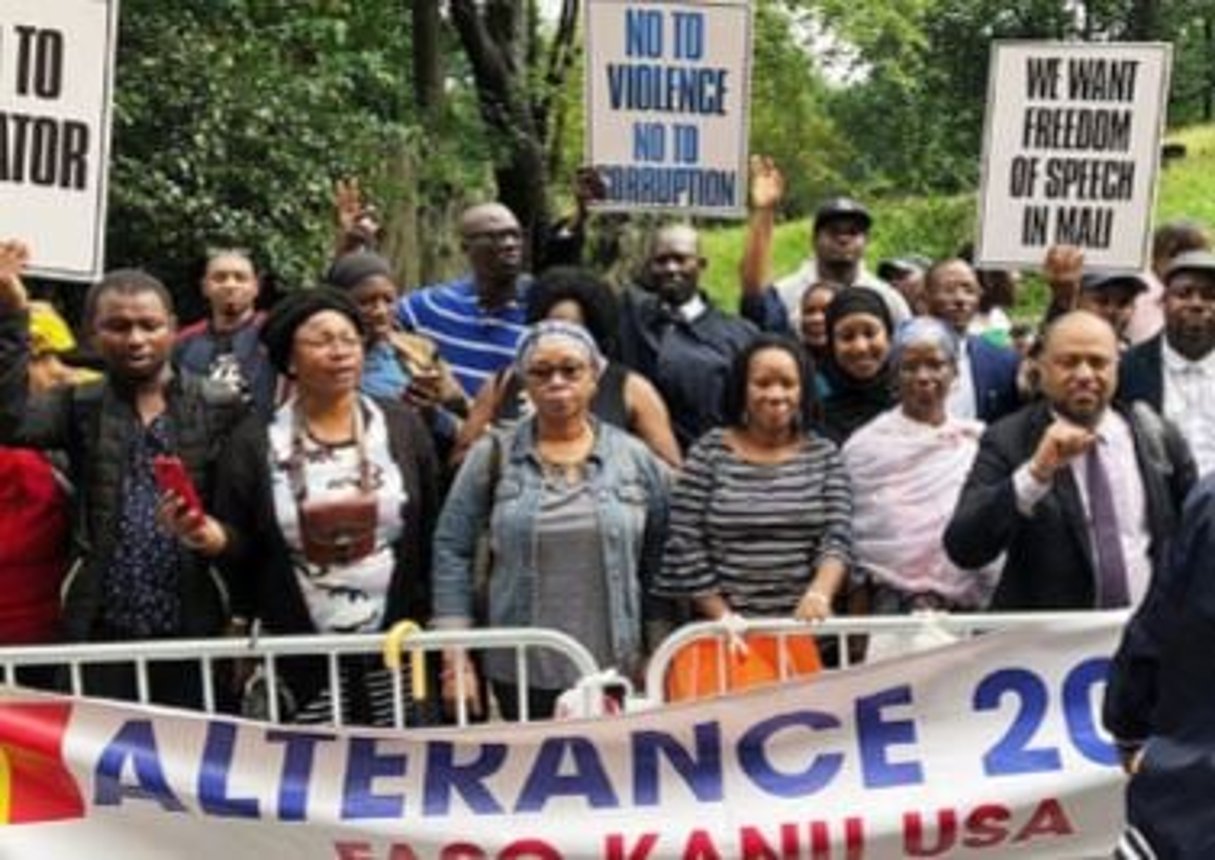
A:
923;260;1021;423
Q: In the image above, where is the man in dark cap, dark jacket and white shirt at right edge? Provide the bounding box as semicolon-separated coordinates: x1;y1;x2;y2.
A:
1119;251;1215;475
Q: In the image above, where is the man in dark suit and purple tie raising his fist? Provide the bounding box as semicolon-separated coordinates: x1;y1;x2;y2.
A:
945;311;1194;610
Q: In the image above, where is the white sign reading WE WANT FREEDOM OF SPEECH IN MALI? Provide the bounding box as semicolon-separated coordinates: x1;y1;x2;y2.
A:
977;43;1172;271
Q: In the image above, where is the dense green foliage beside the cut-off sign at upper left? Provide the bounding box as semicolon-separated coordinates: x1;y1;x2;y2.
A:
108;0;481;316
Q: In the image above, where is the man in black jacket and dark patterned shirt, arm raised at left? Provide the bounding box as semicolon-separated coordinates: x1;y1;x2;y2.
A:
0;242;244;705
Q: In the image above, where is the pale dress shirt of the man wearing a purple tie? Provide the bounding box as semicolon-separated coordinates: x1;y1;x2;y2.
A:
1012;409;1152;606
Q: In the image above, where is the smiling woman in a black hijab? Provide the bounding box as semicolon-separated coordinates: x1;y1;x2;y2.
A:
818;287;894;445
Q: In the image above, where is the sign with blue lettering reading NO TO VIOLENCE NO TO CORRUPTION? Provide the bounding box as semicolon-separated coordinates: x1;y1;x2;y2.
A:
586;0;751;217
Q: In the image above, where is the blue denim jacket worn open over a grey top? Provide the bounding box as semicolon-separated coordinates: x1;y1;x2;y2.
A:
434;418;667;669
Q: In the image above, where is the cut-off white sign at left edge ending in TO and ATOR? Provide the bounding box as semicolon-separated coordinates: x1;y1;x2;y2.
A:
0;0;118;281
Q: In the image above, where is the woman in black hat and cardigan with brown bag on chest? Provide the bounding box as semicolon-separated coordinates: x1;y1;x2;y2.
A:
164;289;439;725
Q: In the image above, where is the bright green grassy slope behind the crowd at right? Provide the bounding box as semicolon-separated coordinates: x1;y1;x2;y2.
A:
703;125;1215;315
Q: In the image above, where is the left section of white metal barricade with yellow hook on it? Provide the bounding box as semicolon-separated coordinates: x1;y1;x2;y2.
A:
0;622;603;728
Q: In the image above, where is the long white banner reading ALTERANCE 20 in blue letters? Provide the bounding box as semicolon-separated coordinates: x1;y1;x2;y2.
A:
0;616;1123;860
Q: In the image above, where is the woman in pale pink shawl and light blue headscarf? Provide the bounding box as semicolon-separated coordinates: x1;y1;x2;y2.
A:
843;317;1000;615
